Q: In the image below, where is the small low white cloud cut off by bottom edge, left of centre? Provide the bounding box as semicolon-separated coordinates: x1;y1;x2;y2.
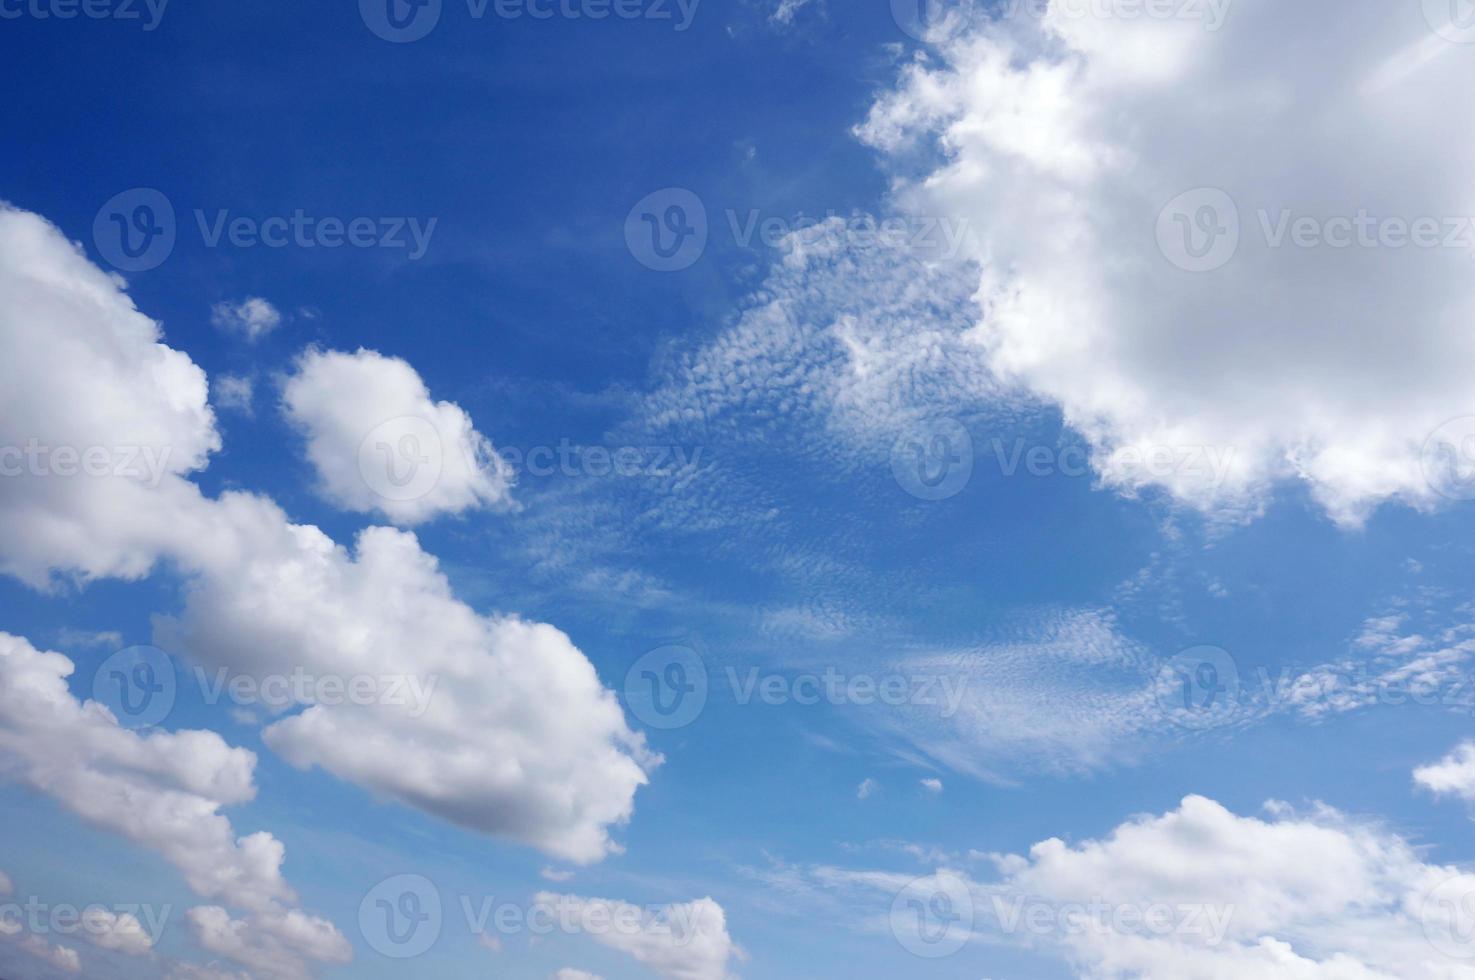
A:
534;893;743;980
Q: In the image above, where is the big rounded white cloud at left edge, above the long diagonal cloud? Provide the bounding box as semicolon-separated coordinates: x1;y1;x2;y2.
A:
0;205;220;586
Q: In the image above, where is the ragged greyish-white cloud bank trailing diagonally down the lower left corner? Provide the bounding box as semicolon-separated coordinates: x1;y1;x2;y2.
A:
0;633;350;980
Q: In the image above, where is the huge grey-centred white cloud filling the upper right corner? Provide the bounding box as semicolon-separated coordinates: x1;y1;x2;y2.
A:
858;0;1475;524
